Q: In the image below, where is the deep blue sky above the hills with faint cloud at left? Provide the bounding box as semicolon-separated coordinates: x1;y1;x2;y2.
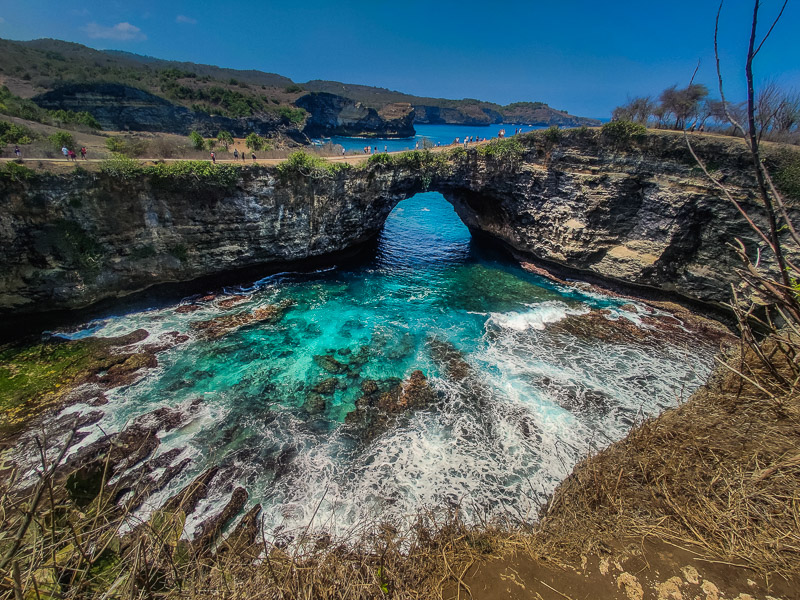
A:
0;0;800;117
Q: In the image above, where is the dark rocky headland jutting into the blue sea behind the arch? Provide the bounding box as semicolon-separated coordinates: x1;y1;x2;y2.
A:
295;92;415;138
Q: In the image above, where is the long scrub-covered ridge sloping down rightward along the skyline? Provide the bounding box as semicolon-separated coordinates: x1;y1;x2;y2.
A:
0;39;597;126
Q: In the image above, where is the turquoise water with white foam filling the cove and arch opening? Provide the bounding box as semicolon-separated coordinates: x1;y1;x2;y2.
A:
59;193;712;535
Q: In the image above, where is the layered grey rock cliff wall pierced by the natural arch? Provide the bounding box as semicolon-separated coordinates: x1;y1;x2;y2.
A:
0;131;788;317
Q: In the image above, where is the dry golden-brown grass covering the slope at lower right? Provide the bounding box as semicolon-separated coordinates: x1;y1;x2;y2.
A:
535;344;800;576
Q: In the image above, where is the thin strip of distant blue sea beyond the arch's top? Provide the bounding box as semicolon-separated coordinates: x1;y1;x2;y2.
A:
317;124;543;152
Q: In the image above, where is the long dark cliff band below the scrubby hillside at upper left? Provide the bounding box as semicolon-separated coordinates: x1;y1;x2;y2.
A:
33;83;308;143
